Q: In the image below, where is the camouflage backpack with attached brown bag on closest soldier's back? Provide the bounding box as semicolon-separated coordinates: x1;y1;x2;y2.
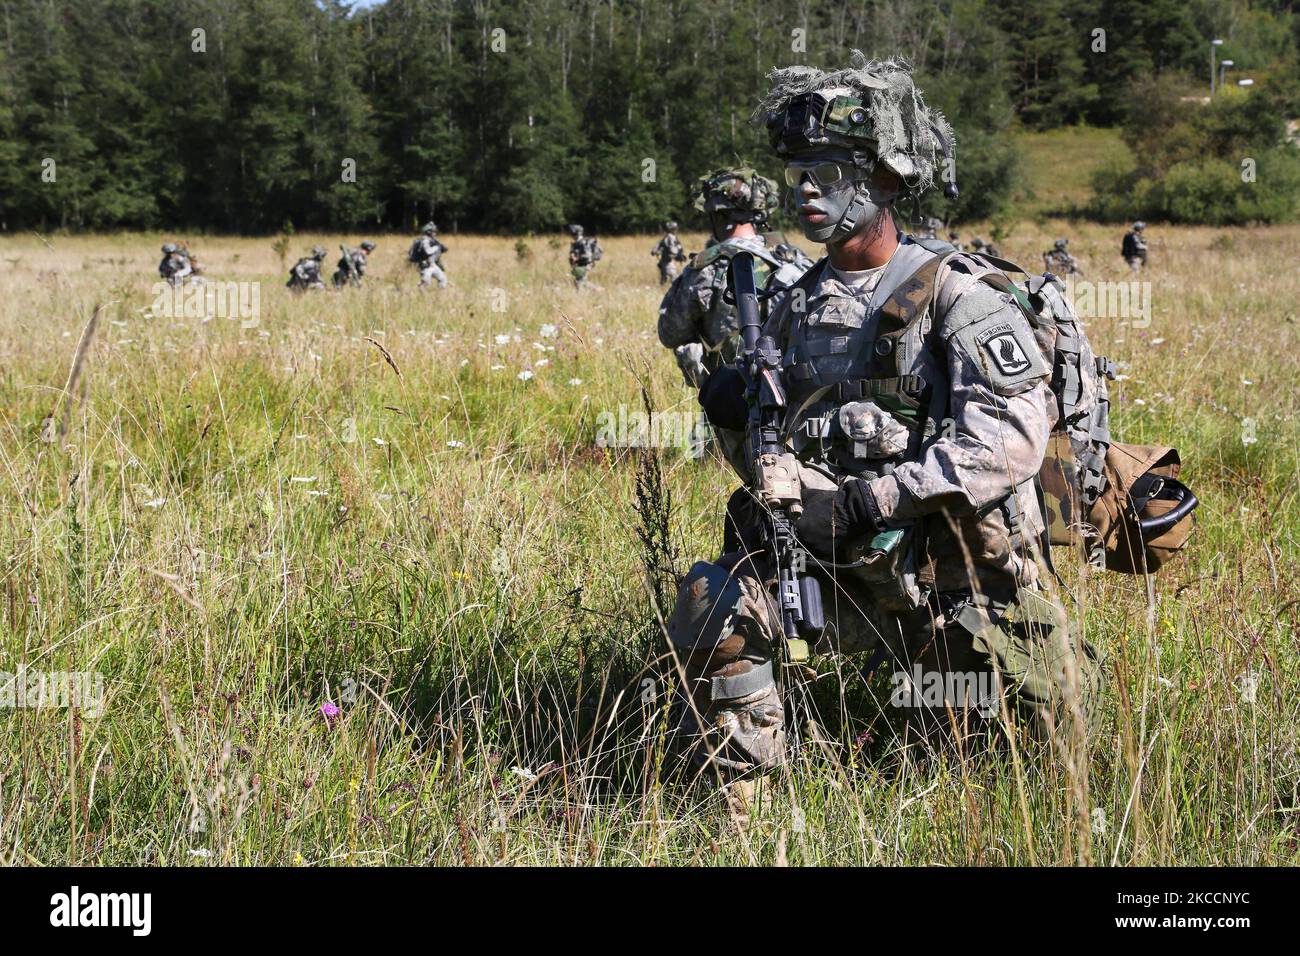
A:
975;255;1199;574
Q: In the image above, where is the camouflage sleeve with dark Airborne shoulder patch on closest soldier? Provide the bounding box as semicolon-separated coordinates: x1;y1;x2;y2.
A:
871;284;1053;524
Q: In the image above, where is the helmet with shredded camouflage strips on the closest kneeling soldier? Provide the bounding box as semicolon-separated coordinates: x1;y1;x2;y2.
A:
754;49;958;235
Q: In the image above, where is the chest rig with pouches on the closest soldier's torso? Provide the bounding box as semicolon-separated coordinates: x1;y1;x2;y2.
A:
784;245;949;479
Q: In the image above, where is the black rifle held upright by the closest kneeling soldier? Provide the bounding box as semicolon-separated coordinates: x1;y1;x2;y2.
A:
731;252;826;661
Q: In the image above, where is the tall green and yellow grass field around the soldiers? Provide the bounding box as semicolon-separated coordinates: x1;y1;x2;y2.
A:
0;221;1300;865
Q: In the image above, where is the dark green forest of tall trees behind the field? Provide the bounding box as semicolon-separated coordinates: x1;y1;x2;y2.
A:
0;0;1300;233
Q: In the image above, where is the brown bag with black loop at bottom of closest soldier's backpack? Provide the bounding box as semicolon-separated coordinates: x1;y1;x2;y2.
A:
1088;441;1200;574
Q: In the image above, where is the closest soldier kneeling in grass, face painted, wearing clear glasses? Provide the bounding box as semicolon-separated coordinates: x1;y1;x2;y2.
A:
667;51;1099;810
